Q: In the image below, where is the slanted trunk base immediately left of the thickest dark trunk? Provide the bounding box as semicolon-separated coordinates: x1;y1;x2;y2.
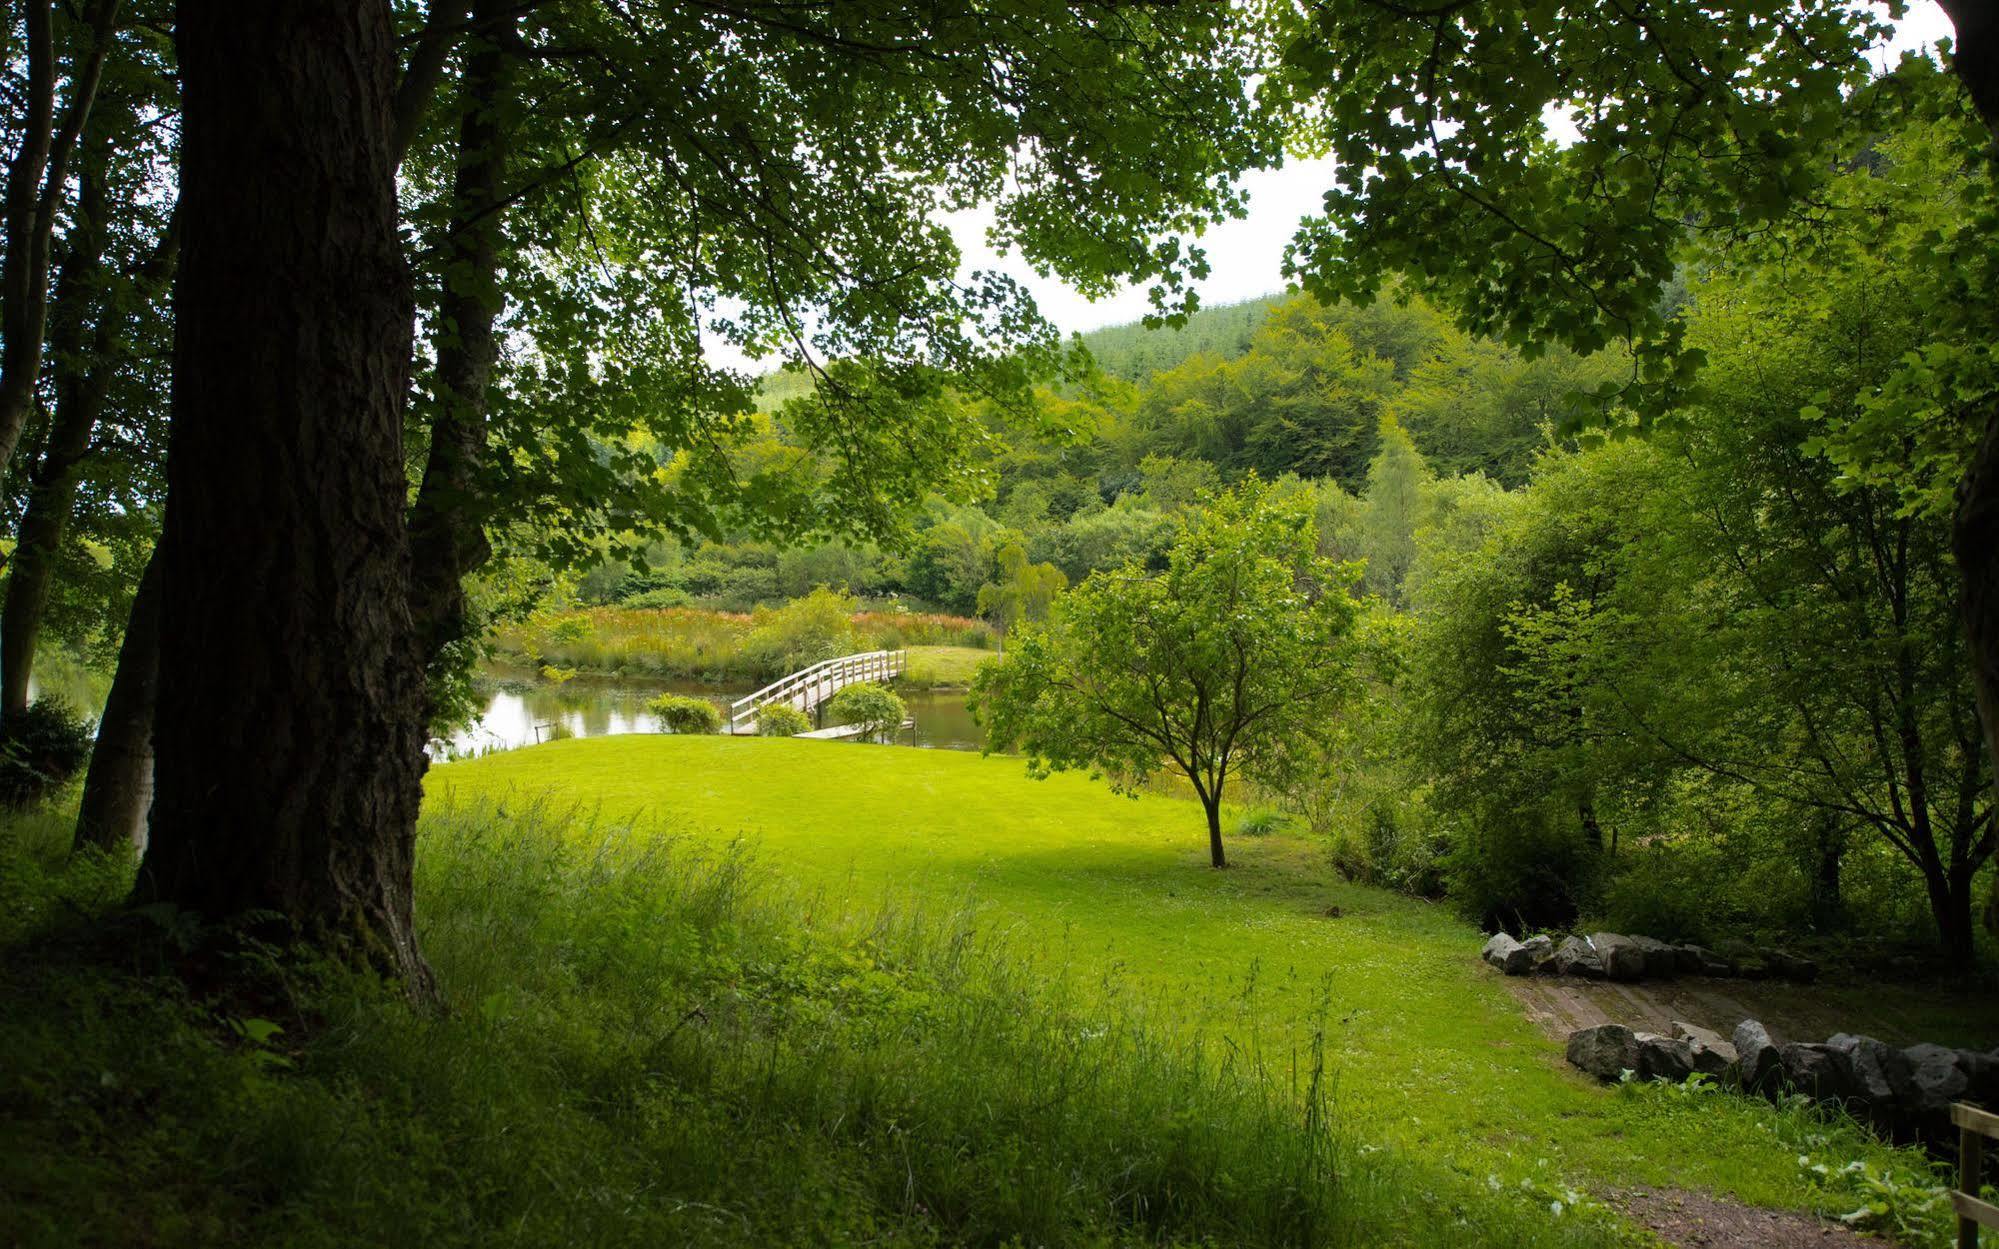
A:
72;550;164;851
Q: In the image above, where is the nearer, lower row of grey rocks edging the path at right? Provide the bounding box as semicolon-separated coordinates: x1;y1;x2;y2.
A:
1569;1019;1999;1137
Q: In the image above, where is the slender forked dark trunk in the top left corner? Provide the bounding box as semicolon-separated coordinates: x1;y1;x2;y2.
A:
0;0;118;470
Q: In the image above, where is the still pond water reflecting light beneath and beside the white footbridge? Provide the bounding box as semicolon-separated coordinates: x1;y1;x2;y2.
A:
447;669;986;759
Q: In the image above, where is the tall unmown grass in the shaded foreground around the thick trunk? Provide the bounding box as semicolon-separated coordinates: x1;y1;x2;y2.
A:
0;801;1603;1245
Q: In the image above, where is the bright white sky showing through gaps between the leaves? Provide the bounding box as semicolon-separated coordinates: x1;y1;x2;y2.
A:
715;0;1951;368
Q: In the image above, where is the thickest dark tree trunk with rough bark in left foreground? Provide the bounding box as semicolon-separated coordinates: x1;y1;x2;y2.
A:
136;0;432;995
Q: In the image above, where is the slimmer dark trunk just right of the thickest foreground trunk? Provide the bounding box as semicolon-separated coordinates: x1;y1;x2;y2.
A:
410;0;516;683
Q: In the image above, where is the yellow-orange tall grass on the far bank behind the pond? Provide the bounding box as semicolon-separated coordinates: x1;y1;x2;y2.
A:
494;600;994;683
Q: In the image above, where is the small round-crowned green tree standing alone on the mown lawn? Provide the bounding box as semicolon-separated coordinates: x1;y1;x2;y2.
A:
972;478;1359;867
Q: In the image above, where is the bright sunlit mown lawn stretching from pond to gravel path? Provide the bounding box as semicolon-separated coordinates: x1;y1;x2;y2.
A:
428;735;1975;1211
